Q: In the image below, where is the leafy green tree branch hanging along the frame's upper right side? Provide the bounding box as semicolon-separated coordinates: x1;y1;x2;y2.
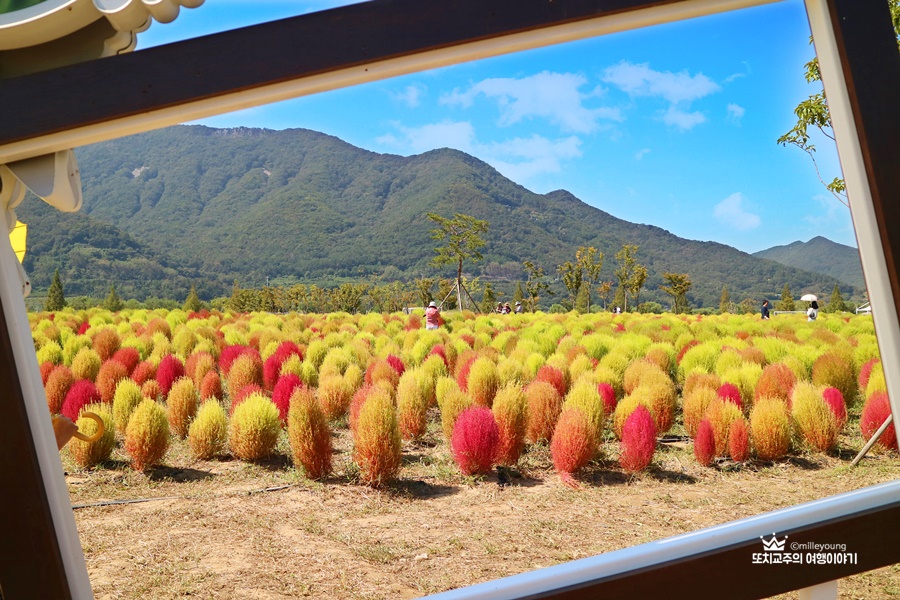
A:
777;0;900;207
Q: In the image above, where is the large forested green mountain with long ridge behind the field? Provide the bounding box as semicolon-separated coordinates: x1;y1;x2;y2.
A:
12;126;857;307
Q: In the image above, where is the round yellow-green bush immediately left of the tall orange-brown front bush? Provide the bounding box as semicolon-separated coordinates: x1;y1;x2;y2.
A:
228;392;281;460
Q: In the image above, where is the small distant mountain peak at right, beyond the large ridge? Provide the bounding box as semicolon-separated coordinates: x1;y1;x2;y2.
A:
753;236;865;289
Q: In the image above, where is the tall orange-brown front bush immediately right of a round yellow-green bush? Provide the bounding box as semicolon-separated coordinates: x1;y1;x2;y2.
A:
288;387;331;479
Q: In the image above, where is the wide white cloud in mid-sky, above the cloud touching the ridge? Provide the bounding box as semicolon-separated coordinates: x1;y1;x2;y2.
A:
441;71;624;133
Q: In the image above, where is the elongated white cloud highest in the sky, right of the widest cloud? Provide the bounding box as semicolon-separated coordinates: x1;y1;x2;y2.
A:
603;61;722;104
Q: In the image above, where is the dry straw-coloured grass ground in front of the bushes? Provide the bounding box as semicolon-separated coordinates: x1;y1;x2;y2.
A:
63;419;900;600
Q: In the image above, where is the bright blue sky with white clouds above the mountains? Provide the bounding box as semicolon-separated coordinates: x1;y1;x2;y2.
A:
138;0;857;252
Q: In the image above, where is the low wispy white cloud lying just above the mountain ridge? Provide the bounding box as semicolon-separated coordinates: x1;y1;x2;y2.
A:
377;121;581;183
